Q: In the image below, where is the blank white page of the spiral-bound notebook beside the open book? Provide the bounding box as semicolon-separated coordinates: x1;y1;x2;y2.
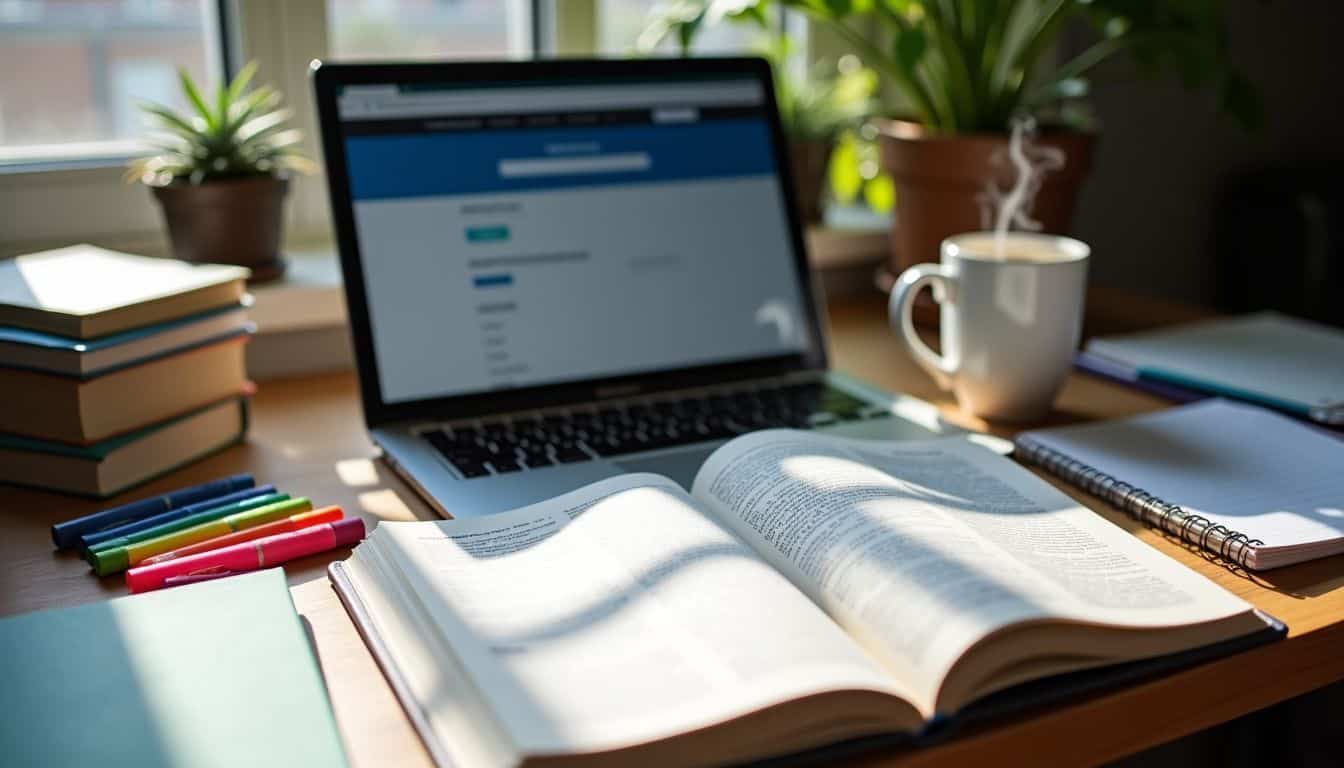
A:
1028;399;1344;547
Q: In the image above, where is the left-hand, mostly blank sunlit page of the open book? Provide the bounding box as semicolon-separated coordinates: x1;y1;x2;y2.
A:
356;475;915;755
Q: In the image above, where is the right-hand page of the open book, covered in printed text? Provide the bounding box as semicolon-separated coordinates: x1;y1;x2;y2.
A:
694;430;1249;707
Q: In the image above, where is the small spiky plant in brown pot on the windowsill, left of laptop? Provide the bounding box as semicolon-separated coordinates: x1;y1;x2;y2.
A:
126;62;313;282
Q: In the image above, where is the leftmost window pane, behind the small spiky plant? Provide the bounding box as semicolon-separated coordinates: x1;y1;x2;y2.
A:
0;0;222;160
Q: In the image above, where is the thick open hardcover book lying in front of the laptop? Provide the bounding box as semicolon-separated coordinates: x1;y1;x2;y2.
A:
331;430;1282;765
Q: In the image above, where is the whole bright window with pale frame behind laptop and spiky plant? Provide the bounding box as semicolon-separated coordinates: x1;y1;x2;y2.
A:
0;0;779;253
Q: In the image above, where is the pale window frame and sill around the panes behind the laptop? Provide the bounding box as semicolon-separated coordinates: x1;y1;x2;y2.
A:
0;0;827;257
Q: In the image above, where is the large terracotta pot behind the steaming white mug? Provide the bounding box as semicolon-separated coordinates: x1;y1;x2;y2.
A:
876;120;1097;282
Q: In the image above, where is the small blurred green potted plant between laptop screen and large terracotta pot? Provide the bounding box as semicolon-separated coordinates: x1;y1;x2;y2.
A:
637;12;878;222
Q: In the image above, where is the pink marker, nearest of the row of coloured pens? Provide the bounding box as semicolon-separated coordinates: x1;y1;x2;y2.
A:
126;518;364;592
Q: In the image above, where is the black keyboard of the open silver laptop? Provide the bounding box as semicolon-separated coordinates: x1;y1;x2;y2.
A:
418;382;890;477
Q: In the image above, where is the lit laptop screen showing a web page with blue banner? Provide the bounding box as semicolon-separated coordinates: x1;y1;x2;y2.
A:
337;75;809;404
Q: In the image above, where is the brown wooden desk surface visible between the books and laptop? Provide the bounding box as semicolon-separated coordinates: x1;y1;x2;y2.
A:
0;294;1344;767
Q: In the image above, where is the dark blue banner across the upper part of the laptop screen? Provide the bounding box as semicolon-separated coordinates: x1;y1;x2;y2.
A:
345;120;774;200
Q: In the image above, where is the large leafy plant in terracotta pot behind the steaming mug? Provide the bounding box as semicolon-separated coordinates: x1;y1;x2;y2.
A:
634;0;1258;279
